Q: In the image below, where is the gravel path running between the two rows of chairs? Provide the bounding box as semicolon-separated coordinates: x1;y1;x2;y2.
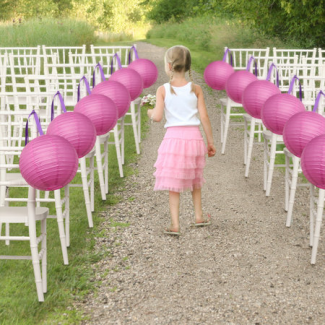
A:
76;43;325;325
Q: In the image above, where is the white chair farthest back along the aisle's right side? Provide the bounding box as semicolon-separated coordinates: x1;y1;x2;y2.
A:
220;48;270;154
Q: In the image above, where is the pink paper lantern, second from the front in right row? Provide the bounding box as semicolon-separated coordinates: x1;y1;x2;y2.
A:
283;112;325;157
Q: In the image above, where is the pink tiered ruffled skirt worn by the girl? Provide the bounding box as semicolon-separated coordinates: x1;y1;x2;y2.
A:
154;126;207;192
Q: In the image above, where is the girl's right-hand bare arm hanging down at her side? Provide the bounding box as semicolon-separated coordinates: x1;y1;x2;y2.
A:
195;85;216;157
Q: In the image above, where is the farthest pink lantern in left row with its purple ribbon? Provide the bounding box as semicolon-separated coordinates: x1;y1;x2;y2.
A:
129;46;158;88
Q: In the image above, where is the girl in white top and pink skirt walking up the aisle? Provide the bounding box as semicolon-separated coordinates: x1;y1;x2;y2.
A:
148;45;216;235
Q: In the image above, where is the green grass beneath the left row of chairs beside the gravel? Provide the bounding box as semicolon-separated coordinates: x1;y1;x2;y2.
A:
0;108;148;325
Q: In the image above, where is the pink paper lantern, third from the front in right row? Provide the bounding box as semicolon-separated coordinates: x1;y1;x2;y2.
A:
261;94;305;135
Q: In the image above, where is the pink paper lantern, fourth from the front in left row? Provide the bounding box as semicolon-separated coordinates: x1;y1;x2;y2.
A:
92;80;131;118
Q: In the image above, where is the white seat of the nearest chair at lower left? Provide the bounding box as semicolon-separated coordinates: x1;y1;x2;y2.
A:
0;207;49;223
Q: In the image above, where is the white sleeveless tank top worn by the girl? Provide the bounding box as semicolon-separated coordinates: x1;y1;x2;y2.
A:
164;82;200;128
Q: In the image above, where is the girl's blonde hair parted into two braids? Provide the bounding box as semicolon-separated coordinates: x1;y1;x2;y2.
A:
165;45;195;95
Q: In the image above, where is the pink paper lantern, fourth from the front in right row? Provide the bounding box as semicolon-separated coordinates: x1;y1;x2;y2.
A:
242;80;281;119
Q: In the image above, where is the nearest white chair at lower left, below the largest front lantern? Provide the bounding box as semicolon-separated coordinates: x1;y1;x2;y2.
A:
0;184;48;302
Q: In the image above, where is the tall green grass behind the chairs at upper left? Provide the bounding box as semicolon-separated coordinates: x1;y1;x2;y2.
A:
0;18;96;47
